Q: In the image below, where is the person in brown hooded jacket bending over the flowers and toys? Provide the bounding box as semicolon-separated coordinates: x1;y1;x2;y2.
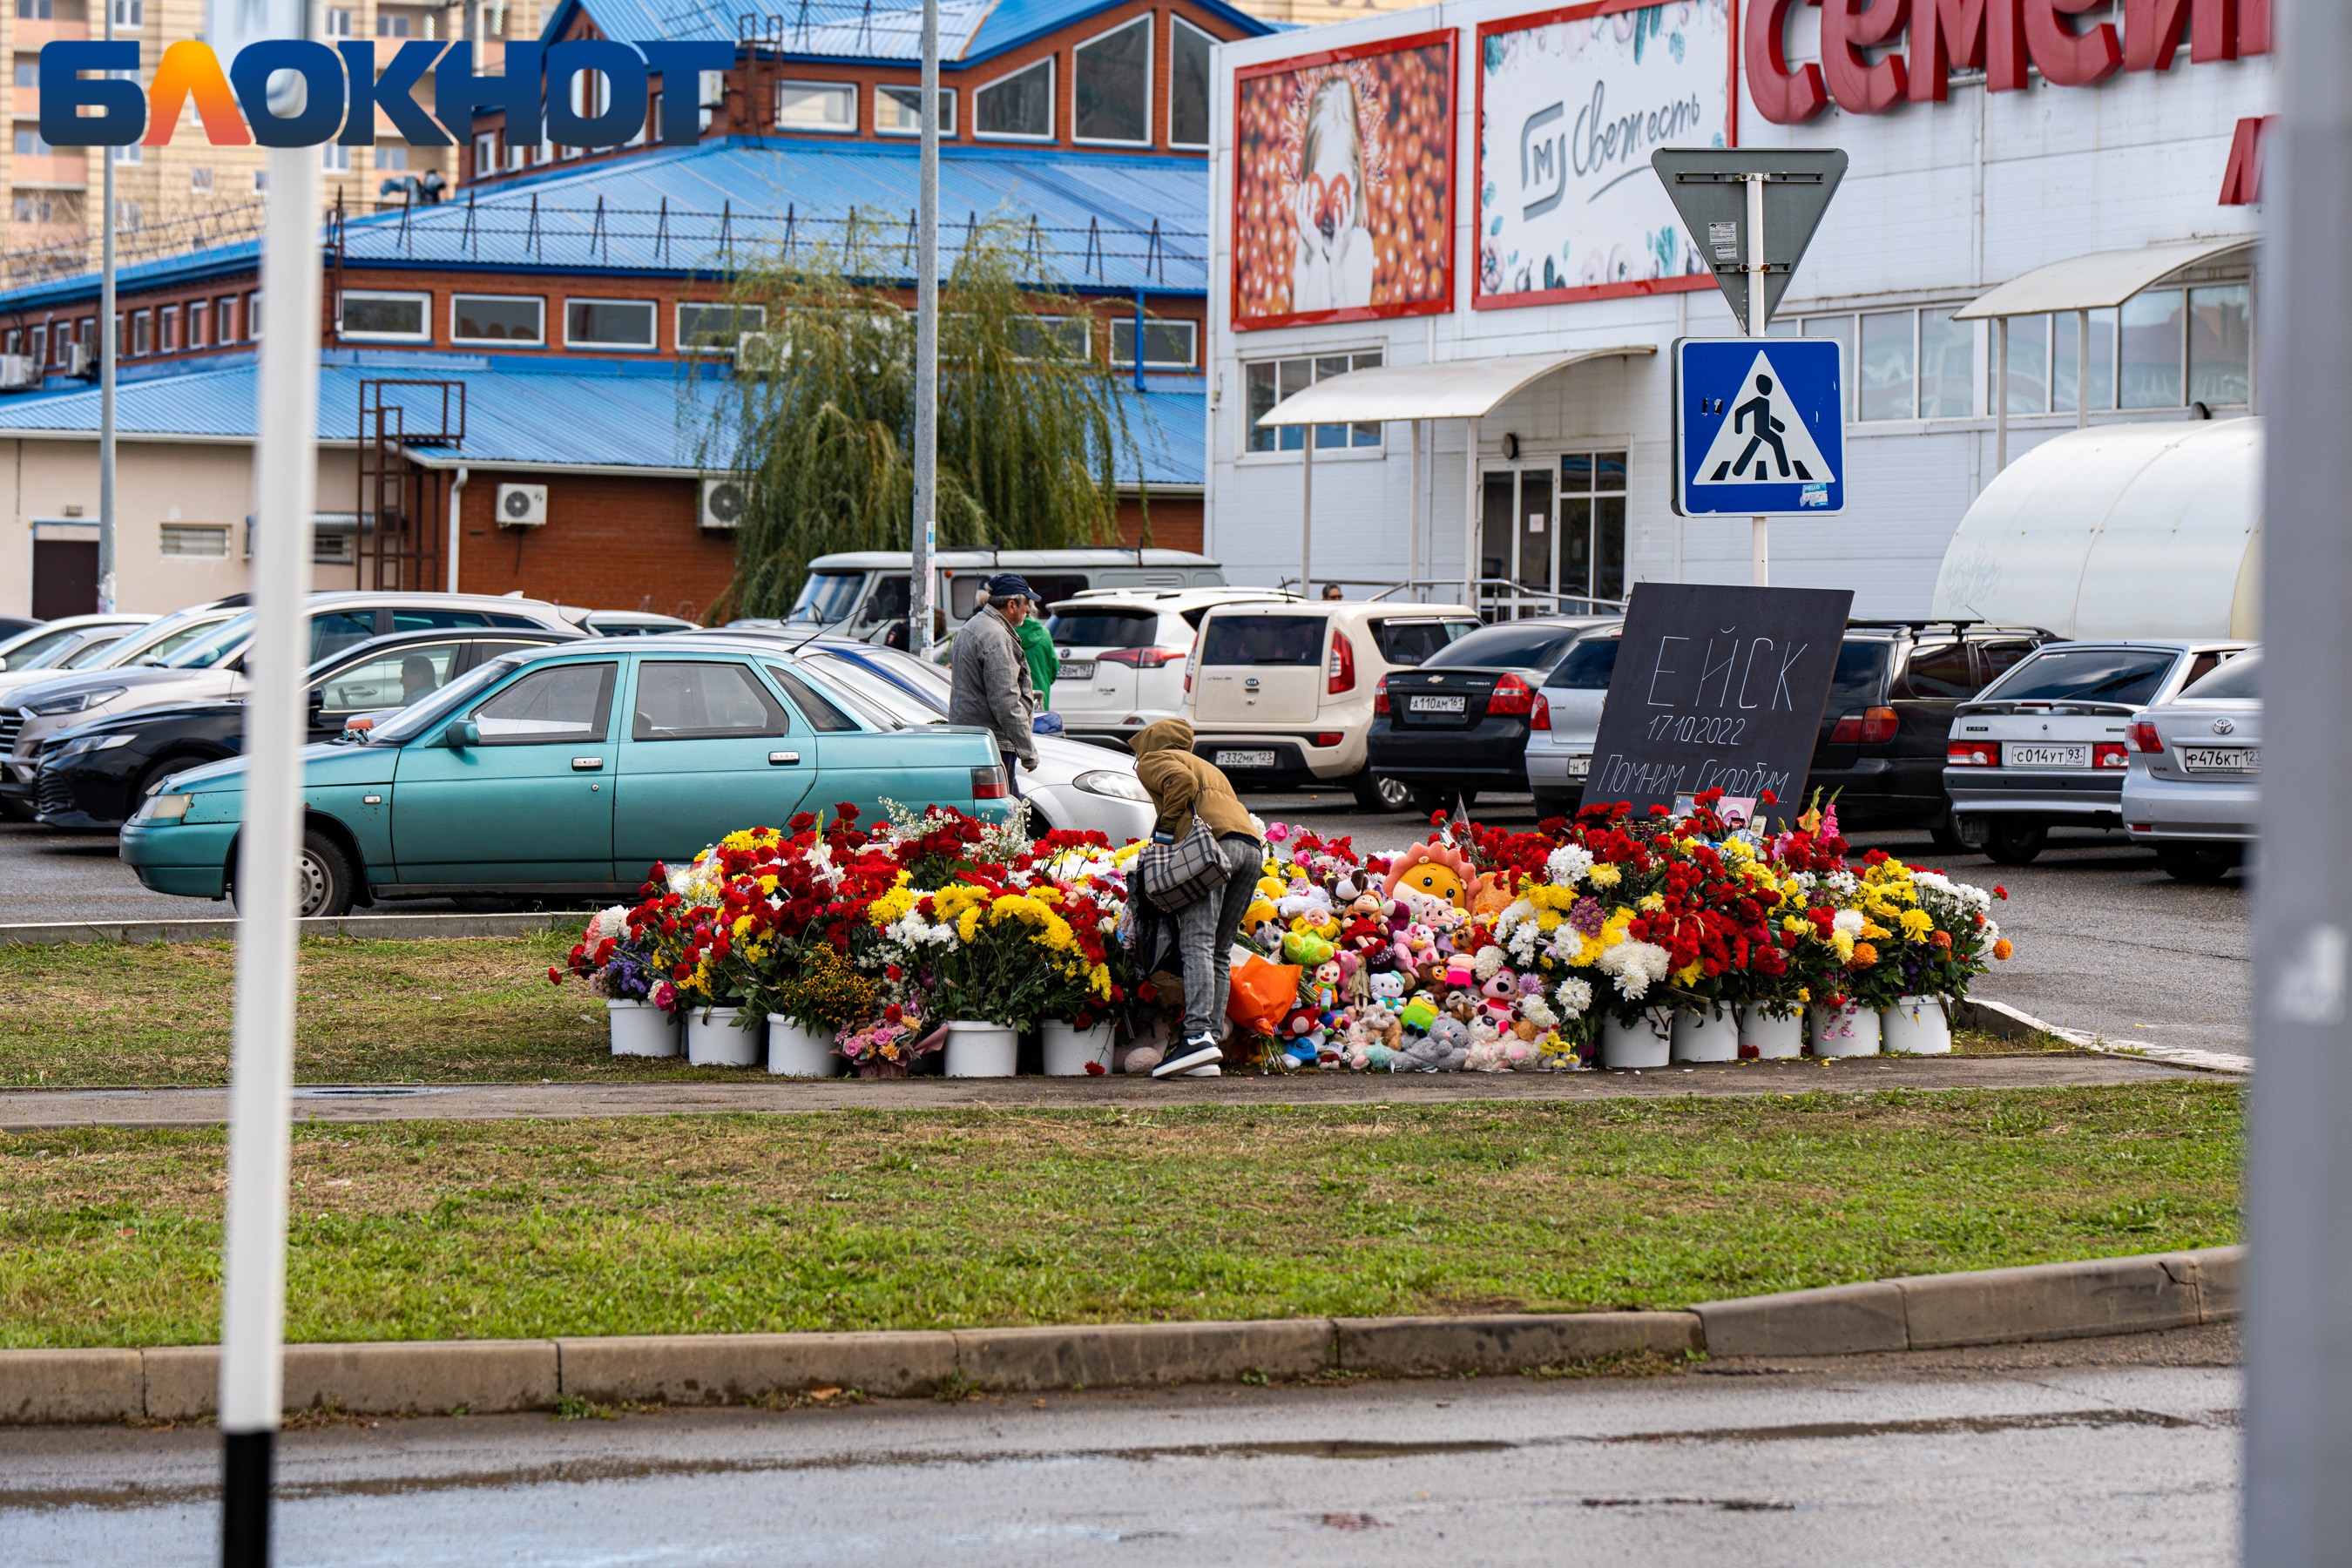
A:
1126;720;1266;1079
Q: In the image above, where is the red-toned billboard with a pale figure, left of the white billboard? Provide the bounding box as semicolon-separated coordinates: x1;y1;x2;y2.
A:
1233;30;1454;332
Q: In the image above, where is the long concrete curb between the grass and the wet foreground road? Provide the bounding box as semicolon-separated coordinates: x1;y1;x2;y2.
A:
0;1246;2247;1424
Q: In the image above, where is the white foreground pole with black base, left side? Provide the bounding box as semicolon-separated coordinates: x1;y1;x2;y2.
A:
221;148;320;1568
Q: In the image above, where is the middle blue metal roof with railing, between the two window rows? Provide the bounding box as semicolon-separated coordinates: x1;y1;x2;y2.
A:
0;137;1209;310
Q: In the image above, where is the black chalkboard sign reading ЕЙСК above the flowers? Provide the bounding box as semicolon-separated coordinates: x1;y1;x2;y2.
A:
1583;583;1854;818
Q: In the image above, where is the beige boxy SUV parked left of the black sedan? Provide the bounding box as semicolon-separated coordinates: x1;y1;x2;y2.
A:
1183;599;1479;811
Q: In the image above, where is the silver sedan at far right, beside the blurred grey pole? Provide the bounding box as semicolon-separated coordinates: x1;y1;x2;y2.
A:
2124;649;2262;882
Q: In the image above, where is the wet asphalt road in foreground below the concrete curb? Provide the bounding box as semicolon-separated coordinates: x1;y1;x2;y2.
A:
0;1330;2241;1568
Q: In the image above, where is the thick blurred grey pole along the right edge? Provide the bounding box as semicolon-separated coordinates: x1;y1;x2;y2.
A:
2239;0;2352;1568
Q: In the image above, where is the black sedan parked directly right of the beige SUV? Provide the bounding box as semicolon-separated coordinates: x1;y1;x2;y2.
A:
1367;616;1619;811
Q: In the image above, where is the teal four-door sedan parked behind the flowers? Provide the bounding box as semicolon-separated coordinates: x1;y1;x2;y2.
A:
122;635;1014;916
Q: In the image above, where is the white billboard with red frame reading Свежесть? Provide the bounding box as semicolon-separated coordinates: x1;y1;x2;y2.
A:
1472;0;1738;310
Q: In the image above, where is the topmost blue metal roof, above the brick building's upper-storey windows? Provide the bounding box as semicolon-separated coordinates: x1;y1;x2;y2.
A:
538;0;1277;71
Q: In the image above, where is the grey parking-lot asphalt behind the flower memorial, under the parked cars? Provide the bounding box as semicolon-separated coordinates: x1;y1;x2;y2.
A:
0;792;2254;1053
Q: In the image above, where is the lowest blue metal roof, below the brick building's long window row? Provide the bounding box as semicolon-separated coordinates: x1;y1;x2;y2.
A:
0;350;1206;484
